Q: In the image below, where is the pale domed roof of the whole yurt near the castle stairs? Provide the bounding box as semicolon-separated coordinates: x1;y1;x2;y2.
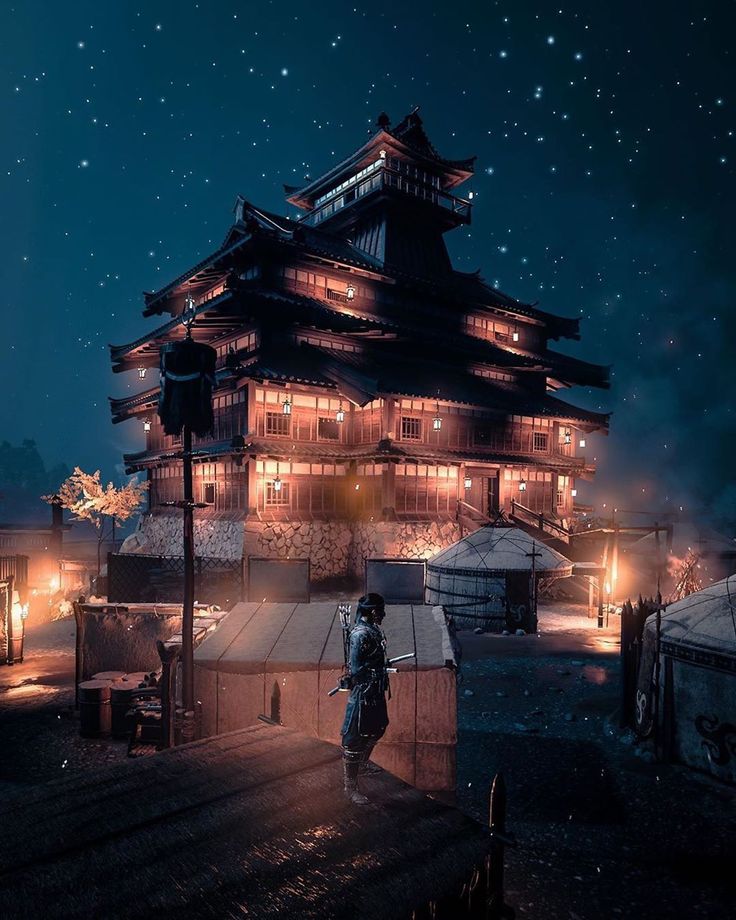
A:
427;525;572;577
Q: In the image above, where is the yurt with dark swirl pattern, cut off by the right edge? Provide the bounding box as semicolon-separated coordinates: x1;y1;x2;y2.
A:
636;575;736;783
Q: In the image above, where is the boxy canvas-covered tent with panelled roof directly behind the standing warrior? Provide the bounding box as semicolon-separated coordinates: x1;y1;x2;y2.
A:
194;602;457;793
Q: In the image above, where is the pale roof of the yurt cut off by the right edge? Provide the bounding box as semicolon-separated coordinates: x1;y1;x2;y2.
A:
647;575;736;658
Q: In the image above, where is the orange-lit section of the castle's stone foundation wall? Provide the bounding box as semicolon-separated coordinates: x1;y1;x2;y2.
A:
245;520;460;581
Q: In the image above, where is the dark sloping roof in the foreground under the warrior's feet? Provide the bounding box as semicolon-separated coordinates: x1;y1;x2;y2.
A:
0;724;490;920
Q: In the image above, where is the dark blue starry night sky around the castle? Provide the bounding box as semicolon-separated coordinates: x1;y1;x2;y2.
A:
0;0;736;522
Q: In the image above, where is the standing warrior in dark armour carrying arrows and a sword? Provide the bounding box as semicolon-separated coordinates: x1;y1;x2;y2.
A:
341;593;391;805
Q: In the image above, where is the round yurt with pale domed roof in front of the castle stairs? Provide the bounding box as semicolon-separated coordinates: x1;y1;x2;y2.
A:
427;525;572;632
